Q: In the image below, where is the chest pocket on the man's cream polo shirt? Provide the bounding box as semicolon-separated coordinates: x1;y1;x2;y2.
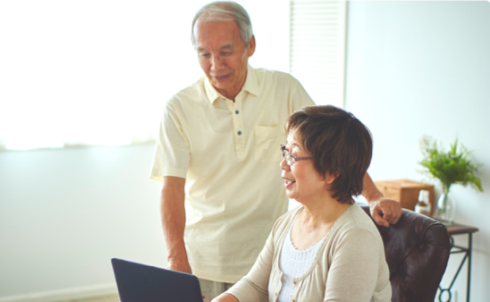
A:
254;126;286;164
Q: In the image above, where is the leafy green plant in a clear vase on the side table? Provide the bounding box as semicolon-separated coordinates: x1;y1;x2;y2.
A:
420;137;483;224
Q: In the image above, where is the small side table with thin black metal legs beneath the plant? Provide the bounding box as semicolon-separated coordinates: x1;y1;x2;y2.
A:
439;224;478;302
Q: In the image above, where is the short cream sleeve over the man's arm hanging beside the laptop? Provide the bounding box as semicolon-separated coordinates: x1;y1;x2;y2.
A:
150;100;190;181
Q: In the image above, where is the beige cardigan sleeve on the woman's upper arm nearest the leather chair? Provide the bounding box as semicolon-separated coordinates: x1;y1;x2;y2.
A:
324;228;384;302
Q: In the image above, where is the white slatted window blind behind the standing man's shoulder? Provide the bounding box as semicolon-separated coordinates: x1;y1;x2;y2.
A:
289;0;347;107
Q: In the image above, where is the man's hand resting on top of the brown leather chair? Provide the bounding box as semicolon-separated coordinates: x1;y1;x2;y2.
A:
368;197;402;227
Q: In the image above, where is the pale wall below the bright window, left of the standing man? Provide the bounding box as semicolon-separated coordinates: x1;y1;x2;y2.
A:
0;145;166;300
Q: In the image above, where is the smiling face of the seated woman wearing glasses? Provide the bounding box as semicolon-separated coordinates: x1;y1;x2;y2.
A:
280;130;327;204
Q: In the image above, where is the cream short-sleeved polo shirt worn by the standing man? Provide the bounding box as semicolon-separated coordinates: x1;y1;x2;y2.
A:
151;66;314;283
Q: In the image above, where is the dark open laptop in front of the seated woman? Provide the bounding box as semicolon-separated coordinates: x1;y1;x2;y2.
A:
111;258;203;302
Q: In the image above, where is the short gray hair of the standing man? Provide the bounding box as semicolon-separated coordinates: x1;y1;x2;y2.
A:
191;1;253;48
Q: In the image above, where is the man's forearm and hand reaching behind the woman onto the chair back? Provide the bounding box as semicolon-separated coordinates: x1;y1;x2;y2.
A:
362;172;402;227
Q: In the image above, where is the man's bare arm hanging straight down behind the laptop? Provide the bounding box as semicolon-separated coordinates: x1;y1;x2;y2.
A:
160;176;192;274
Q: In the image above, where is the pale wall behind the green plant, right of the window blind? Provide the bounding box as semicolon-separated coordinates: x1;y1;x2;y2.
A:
346;0;490;301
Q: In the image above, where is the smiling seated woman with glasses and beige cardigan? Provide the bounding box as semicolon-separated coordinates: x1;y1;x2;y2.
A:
213;106;391;302
